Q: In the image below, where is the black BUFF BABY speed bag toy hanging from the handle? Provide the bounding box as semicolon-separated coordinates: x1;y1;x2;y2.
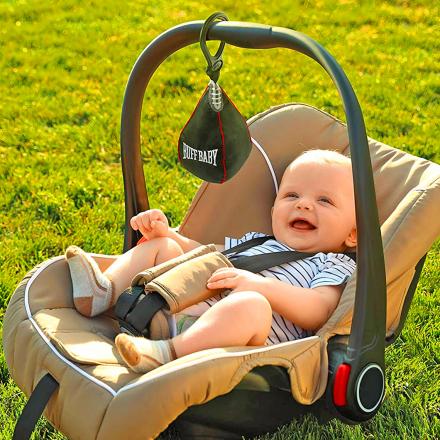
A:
178;13;252;183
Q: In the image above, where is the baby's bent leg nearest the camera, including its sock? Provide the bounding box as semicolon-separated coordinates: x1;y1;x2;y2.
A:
116;292;272;373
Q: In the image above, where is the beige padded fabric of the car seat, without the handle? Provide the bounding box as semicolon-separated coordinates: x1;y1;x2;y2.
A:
3;104;440;439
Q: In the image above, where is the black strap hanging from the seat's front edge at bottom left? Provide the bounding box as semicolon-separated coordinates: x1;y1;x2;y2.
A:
12;373;59;440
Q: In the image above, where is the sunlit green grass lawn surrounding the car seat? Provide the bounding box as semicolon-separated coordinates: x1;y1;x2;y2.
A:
0;0;440;440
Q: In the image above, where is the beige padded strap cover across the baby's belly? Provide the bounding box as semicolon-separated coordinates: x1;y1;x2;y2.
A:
145;251;232;313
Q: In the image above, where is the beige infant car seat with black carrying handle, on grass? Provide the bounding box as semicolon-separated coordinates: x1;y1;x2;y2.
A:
3;18;440;440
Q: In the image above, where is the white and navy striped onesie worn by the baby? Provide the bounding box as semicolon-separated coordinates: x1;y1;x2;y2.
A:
177;232;356;345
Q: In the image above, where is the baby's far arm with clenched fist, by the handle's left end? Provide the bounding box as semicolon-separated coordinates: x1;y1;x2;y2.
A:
130;209;223;252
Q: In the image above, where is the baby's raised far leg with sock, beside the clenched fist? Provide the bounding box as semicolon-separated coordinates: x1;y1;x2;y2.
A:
66;237;183;317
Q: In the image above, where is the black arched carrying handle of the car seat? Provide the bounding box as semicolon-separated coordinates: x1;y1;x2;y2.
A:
121;21;386;420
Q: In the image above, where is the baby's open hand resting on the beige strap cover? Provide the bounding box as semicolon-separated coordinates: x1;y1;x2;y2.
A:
207;267;263;292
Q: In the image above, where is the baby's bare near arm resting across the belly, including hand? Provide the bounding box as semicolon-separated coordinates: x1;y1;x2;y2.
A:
208;268;343;330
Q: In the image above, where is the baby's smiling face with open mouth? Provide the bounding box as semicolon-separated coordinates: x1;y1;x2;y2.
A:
272;162;356;252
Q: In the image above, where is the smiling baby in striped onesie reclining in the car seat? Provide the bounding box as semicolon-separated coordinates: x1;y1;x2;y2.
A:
66;150;357;372
